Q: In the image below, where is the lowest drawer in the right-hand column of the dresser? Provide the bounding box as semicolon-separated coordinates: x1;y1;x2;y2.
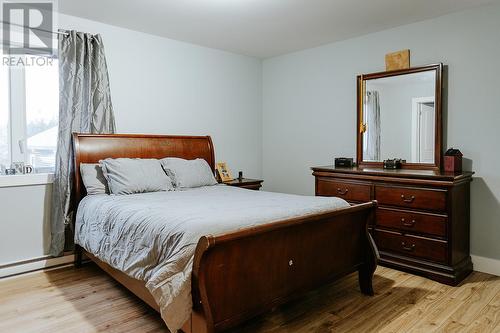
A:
375;230;448;263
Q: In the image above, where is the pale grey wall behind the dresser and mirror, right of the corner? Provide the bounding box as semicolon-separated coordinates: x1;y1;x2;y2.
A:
263;5;500;259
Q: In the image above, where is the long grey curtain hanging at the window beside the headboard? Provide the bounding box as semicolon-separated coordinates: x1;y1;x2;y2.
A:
50;31;115;256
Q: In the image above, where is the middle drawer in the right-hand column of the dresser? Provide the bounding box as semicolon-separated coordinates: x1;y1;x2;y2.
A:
377;208;447;237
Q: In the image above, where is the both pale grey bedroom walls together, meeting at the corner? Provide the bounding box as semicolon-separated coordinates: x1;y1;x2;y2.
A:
0;5;500;272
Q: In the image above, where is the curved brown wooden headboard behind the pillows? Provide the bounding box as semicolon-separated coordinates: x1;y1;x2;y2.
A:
73;133;215;207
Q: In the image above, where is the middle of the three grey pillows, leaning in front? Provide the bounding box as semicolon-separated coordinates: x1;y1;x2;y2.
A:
99;158;173;194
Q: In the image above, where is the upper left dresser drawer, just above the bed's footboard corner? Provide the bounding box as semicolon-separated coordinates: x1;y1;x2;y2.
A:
316;178;371;202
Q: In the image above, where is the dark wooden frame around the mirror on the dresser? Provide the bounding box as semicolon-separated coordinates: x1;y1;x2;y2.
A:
356;63;443;170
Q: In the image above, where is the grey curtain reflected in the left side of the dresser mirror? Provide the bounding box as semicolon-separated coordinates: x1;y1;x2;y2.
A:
363;91;380;161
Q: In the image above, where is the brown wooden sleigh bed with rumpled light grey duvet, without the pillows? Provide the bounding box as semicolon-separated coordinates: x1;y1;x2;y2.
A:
73;134;377;333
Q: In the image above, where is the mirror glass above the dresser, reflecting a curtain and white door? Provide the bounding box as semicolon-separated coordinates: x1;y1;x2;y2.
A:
363;70;436;164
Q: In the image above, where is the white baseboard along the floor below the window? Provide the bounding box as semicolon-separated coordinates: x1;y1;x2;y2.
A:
0;254;75;278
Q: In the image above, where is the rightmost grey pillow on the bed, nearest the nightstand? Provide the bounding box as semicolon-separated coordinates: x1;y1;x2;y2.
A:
160;157;217;188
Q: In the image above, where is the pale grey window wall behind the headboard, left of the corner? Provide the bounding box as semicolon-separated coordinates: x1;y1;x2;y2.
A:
0;15;262;268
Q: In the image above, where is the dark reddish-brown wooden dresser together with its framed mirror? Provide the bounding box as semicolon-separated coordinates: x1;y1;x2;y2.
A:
312;64;473;285
